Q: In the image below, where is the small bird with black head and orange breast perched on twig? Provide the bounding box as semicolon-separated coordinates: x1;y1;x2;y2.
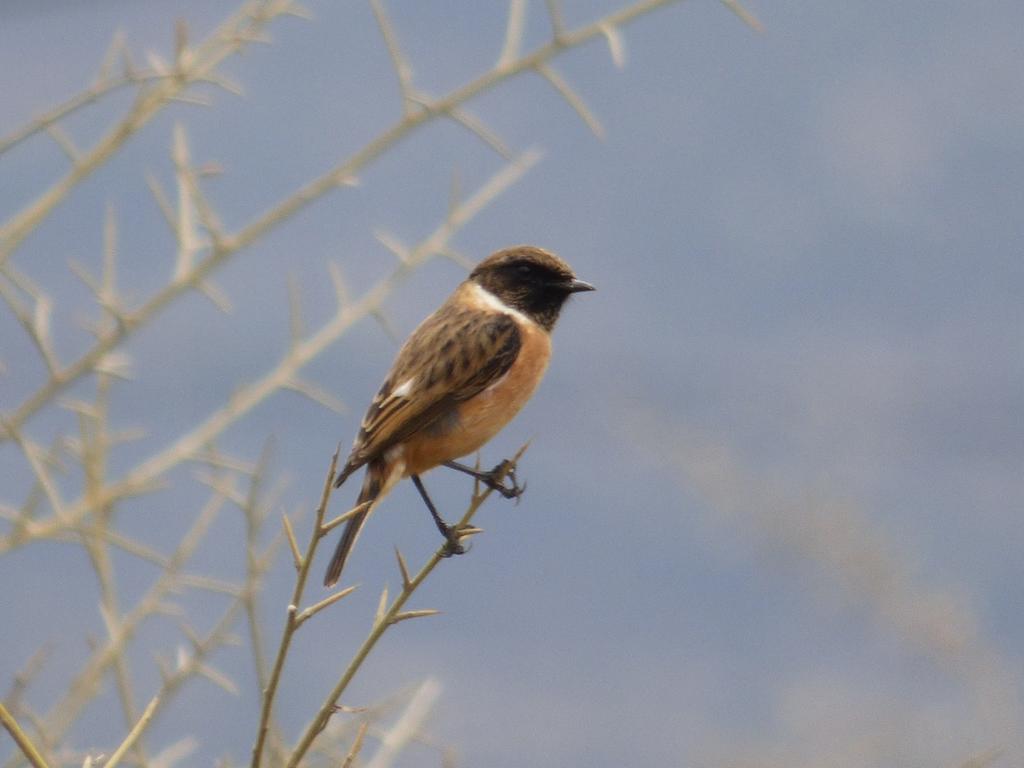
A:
324;245;595;587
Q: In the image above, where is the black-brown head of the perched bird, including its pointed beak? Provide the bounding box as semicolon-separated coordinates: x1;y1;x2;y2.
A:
469;246;594;331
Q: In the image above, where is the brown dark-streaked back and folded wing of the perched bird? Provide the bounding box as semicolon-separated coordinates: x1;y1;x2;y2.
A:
338;304;522;485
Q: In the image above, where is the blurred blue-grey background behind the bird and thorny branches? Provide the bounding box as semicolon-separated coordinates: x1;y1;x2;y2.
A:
0;0;1024;767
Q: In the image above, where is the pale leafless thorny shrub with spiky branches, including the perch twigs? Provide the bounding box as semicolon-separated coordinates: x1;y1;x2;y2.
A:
0;0;752;768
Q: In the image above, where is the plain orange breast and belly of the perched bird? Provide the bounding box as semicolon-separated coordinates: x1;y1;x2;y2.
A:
403;324;551;477
